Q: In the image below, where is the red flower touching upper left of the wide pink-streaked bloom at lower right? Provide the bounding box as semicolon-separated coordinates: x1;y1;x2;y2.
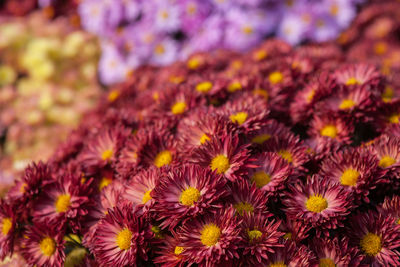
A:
248;152;293;197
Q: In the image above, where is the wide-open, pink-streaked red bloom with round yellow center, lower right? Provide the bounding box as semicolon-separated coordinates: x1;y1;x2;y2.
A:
283;176;352;230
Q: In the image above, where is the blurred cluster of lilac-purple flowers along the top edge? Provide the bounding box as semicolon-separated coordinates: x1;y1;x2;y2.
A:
78;0;362;84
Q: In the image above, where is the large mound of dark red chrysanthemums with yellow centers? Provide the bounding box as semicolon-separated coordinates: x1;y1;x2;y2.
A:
0;3;400;267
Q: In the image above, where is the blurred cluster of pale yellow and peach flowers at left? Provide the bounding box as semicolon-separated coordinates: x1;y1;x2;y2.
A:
0;12;100;191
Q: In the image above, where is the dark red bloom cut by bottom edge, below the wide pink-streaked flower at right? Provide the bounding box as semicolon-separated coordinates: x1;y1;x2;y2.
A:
310;237;361;267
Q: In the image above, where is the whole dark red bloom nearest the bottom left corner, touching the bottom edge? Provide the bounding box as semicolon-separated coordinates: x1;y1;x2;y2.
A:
21;224;65;266
